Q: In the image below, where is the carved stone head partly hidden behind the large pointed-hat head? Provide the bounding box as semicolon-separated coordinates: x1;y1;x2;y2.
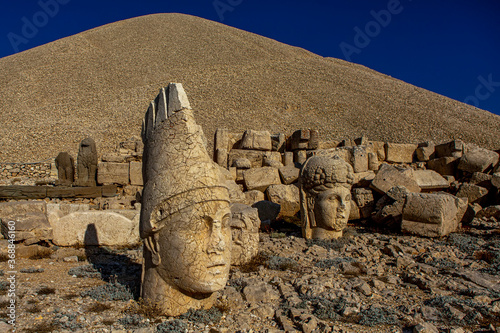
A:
231;203;260;265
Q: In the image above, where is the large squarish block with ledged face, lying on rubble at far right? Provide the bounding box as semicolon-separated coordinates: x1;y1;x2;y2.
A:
401;193;465;237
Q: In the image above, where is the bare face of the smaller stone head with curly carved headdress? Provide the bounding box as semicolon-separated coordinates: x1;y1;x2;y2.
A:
313;186;351;231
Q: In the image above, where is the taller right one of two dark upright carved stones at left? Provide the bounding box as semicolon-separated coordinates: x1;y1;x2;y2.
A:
76;138;97;186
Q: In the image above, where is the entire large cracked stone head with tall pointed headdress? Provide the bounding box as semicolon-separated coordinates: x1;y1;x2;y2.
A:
140;83;231;316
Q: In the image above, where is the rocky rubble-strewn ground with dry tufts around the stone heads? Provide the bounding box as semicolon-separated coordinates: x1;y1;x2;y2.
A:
0;218;500;333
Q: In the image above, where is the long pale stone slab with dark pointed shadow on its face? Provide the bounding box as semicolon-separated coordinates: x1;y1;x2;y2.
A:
50;210;139;246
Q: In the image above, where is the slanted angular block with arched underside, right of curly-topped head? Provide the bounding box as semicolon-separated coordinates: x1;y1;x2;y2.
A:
370;164;420;193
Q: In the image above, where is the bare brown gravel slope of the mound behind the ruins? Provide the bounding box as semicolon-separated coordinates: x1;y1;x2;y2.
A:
0;14;500;162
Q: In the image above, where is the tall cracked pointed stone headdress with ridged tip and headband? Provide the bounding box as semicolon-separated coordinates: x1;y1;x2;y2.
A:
140;83;229;238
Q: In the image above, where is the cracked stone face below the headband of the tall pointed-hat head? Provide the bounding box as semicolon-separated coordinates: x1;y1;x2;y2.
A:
155;201;231;293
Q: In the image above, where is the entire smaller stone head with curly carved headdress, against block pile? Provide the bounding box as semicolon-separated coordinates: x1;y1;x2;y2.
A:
300;155;354;239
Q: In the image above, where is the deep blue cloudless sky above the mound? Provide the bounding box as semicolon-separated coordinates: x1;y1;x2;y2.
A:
0;0;500;114
